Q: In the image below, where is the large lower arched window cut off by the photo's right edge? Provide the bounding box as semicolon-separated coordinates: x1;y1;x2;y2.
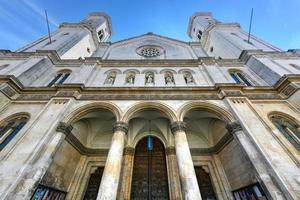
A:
270;115;300;151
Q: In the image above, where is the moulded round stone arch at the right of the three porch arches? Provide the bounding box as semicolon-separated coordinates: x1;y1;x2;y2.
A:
178;101;235;123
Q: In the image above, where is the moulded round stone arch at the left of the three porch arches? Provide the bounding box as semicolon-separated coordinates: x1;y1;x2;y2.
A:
62;102;121;124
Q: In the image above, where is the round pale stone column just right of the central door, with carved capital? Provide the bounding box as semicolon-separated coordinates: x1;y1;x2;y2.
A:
171;122;201;200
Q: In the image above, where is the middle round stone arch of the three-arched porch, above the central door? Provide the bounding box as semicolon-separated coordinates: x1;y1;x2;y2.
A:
122;102;177;123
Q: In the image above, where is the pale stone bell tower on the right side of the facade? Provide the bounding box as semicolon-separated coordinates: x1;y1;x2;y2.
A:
188;12;281;59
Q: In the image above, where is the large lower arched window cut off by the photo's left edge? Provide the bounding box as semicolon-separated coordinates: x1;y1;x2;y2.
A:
0;115;29;151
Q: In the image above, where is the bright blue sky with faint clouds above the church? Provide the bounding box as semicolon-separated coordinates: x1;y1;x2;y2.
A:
0;0;300;50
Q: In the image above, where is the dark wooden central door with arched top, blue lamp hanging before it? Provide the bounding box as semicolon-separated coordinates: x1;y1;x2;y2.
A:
131;136;169;200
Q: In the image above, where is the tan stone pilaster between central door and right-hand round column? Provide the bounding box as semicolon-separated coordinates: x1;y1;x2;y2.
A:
166;146;182;200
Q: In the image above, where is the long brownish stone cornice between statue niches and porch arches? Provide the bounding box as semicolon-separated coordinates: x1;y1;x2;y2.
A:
0;75;300;101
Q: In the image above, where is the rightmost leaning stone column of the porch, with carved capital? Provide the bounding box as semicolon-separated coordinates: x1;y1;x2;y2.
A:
226;122;285;200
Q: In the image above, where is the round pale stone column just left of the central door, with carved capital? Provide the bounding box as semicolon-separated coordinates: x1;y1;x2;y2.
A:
97;122;128;200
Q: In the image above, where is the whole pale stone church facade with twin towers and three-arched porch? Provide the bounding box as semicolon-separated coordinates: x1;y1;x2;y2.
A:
0;13;300;200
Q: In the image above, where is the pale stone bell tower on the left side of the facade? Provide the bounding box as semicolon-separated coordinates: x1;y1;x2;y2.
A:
17;13;112;59
